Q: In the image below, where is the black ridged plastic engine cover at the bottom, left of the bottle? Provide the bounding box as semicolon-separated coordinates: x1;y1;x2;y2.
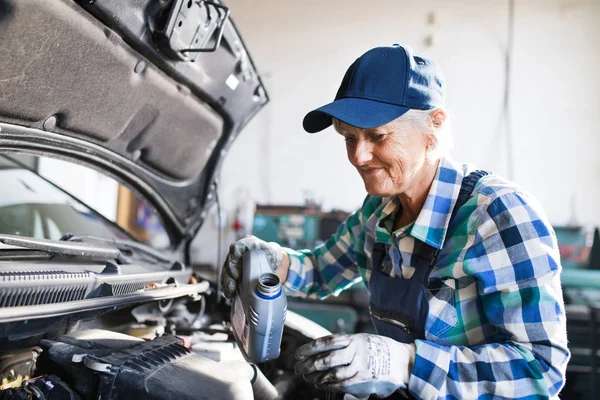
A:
41;330;253;400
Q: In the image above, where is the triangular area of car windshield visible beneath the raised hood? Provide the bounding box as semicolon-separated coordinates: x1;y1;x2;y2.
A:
0;155;131;240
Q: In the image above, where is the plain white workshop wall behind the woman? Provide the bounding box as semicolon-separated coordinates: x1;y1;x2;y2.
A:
221;0;600;224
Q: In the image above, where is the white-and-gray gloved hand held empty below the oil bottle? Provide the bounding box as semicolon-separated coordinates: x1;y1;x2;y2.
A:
294;333;416;397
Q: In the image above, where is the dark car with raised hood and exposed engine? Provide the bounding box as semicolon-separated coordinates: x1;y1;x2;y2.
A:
0;0;327;399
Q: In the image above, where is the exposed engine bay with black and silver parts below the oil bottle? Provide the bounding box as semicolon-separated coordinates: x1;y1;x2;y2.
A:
0;282;334;400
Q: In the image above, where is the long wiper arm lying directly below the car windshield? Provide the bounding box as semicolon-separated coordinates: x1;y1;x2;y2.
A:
0;234;127;263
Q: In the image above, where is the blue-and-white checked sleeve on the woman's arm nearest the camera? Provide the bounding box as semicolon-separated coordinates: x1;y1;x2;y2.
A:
409;190;570;399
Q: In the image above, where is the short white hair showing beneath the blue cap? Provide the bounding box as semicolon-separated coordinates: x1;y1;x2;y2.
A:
333;108;453;158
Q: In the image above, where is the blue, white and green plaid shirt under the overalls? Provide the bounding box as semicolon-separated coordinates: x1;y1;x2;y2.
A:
285;159;570;399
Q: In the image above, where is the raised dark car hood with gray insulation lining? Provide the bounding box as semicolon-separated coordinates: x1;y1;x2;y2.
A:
0;0;268;245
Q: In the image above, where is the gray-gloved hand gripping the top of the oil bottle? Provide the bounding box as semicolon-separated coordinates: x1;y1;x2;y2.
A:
221;236;283;299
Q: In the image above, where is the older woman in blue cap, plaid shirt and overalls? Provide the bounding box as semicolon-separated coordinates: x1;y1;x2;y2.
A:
221;45;569;399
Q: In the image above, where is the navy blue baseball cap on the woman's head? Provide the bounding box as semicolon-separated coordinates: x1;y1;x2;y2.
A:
302;44;445;133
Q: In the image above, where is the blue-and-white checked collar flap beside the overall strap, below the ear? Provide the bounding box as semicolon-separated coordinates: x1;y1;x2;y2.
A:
410;158;466;249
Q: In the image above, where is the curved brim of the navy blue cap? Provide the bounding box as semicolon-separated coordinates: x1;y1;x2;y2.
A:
302;97;410;133
